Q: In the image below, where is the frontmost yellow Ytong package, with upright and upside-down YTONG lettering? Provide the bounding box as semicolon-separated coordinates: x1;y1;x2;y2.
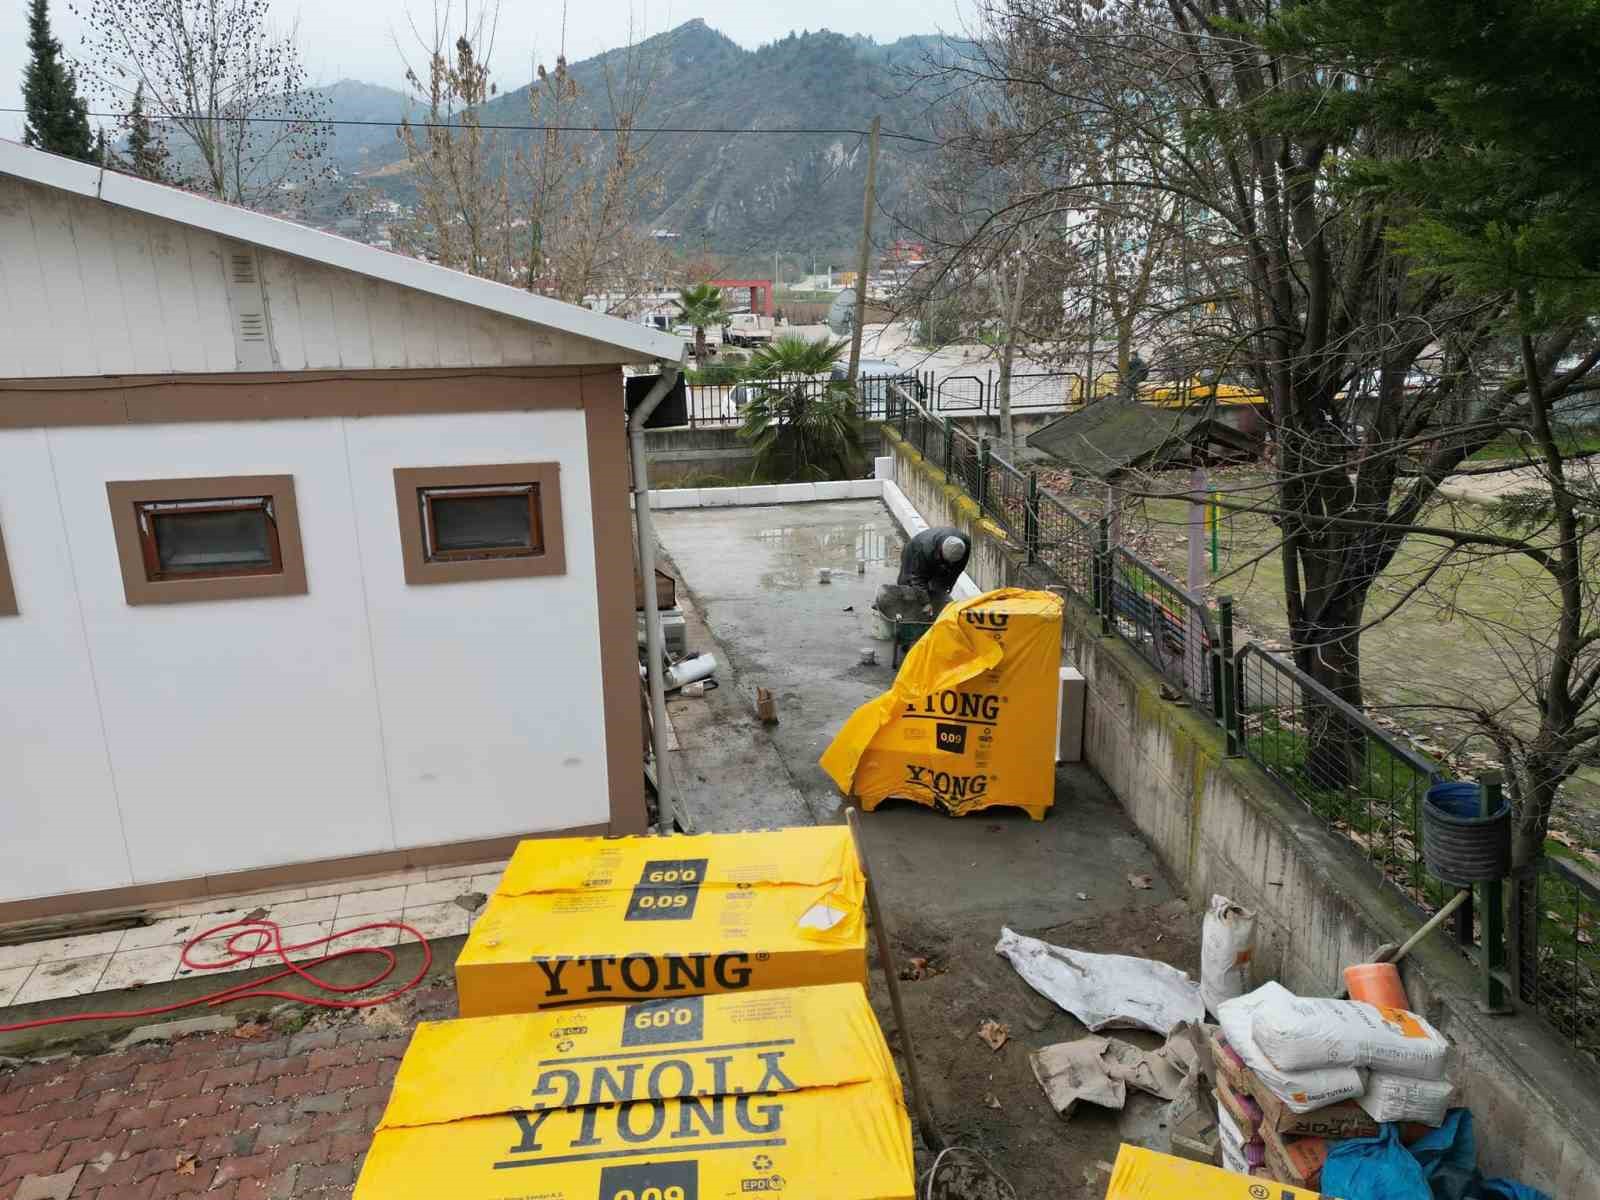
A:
355;984;915;1200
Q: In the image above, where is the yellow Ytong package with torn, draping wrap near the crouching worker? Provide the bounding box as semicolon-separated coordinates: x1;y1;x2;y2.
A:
822;587;1061;821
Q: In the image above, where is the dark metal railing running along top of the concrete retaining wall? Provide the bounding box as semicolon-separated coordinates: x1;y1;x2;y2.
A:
888;394;1600;1062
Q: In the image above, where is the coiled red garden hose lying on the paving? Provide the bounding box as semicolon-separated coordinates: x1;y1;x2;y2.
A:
0;918;434;1034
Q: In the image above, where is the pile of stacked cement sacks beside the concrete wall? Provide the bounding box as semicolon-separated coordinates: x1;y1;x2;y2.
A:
1211;984;1451;1187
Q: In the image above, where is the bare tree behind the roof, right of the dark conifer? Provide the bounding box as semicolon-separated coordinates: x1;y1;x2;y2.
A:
72;0;333;206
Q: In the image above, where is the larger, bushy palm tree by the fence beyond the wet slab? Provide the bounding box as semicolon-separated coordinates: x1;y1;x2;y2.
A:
739;334;864;480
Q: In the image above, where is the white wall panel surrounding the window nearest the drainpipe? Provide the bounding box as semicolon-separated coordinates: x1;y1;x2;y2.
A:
346;411;611;845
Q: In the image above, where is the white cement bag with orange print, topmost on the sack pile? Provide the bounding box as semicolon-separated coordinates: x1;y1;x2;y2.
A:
1251;992;1450;1078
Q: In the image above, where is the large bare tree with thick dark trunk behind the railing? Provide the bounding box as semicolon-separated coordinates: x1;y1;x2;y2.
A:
947;0;1582;800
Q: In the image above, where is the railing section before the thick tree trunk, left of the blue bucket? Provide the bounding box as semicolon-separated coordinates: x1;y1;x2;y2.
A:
1229;643;1456;912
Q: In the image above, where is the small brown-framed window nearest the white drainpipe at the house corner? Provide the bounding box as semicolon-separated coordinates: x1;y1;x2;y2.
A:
395;462;566;584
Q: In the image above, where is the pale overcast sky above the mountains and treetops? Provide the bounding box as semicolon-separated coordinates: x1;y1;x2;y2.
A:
0;0;962;138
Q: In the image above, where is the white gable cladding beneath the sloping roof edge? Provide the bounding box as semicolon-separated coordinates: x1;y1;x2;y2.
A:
0;178;630;378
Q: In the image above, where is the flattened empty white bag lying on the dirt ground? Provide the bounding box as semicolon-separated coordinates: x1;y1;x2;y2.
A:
995;930;1205;1037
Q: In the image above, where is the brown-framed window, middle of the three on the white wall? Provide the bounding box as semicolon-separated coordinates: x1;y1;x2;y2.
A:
106;475;306;605
